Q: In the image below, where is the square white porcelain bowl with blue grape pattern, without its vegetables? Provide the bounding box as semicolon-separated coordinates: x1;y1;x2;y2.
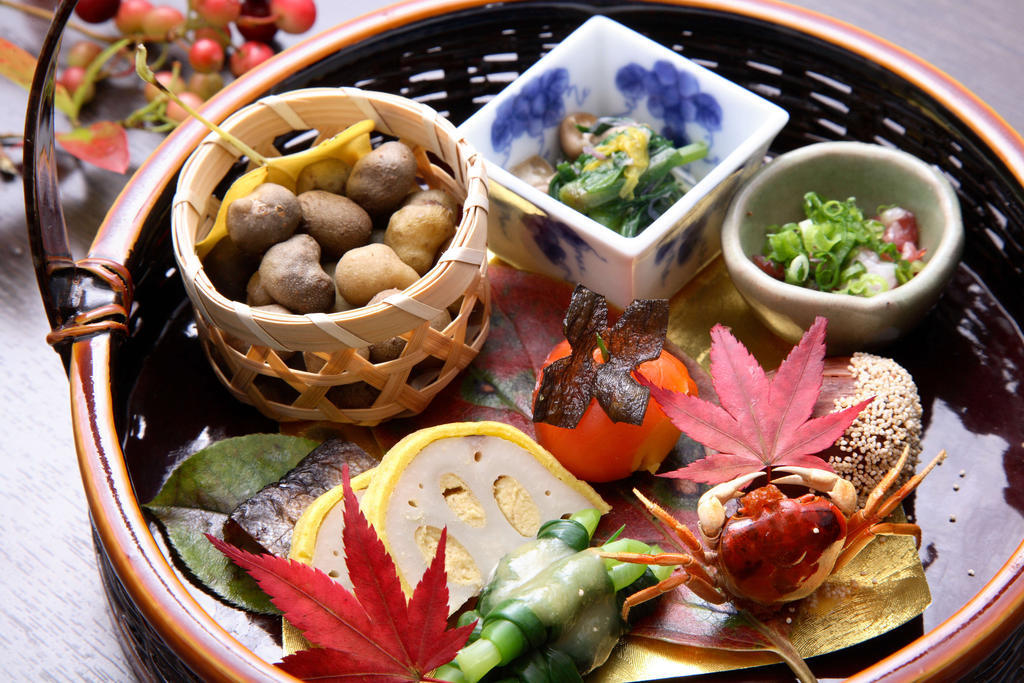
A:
459;16;788;306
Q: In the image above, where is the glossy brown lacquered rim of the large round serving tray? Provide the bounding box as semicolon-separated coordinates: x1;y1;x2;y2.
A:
69;0;1024;681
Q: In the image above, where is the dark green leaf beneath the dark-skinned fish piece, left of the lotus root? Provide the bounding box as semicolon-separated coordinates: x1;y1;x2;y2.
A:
144;434;316;614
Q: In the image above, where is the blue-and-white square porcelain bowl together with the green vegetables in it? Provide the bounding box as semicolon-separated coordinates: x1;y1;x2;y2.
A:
459;16;788;307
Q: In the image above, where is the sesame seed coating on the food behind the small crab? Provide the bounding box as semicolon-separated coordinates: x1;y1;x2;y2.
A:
828;353;922;505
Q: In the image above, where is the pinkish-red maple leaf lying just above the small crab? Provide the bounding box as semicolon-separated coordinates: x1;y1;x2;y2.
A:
639;317;873;484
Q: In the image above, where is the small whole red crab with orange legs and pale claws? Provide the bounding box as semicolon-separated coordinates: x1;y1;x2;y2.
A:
606;451;946;618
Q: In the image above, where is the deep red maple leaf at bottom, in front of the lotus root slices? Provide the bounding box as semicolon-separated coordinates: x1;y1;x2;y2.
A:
214;466;473;683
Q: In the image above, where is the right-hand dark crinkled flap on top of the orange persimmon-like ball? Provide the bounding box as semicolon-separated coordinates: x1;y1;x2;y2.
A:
594;299;669;425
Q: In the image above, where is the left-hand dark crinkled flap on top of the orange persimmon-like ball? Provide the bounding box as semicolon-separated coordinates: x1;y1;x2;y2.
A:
534;285;608;428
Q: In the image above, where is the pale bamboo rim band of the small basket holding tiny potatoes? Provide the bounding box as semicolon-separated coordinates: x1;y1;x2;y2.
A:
171;87;487;351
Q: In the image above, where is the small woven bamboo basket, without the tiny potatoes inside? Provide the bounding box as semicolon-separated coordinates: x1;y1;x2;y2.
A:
171;88;490;425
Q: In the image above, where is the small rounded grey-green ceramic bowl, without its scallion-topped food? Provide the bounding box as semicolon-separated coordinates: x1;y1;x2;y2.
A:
722;142;964;353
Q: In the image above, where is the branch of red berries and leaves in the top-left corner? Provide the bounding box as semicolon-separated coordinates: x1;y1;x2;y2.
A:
0;0;316;172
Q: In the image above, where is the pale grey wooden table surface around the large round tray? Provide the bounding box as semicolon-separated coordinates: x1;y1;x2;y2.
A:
0;0;1024;681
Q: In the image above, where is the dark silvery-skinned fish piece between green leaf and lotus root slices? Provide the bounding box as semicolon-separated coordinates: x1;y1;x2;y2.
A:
224;439;377;556
